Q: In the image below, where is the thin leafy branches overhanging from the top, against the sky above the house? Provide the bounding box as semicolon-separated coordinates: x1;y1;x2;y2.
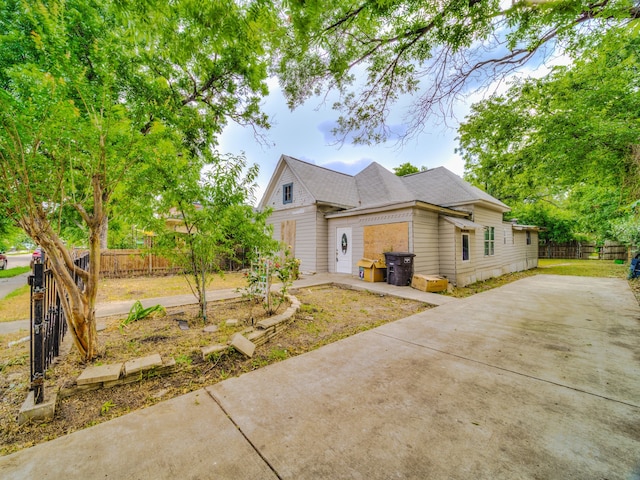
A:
278;0;640;142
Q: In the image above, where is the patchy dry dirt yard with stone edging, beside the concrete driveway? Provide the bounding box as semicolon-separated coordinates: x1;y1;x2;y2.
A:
0;286;429;455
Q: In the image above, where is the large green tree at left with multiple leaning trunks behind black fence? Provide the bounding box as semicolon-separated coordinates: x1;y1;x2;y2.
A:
0;0;277;360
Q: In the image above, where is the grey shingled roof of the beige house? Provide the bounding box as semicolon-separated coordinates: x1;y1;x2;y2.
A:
260;155;509;212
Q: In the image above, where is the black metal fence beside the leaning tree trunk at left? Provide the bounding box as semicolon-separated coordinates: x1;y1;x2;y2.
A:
29;251;89;404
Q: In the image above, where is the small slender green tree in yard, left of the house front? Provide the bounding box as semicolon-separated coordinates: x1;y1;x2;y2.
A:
157;155;277;323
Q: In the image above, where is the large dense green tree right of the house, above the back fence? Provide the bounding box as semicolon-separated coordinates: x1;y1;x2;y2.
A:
459;30;640;240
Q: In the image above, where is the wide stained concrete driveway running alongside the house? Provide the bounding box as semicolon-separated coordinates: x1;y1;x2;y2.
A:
0;275;640;479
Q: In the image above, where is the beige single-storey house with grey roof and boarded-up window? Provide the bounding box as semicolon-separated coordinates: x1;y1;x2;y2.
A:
258;155;538;286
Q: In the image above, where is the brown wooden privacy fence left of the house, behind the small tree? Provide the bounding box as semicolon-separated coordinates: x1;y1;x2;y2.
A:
100;249;249;278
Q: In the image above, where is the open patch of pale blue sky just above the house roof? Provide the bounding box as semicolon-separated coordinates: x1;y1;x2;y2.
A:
218;80;469;204
